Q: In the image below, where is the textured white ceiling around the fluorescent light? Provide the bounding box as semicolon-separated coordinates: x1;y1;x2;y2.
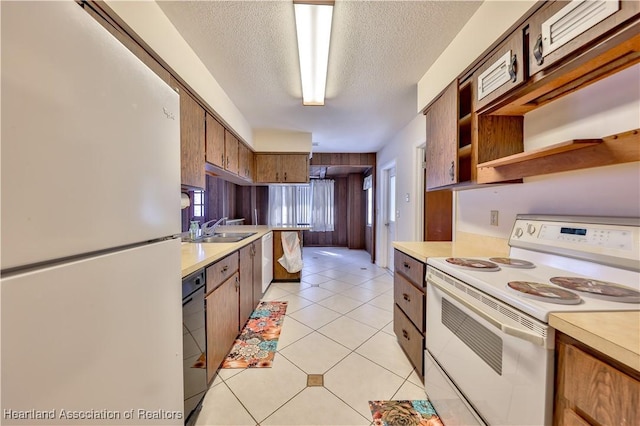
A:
158;0;481;152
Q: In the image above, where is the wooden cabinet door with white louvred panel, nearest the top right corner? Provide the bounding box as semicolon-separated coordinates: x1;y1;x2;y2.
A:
529;0;640;75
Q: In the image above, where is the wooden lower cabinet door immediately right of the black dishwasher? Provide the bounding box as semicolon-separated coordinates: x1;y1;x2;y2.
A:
205;272;239;383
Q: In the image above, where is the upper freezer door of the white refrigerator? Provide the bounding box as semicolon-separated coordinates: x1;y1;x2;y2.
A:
0;1;180;270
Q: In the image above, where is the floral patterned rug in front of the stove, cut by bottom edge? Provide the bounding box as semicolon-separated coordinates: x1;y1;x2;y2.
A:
369;400;443;426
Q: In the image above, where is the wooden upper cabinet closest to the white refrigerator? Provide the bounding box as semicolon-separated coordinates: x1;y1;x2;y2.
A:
171;78;206;188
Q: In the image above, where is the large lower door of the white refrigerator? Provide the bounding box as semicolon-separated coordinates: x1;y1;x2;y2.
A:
0;239;184;425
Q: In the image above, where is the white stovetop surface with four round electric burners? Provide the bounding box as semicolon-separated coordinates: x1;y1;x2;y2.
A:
427;257;640;323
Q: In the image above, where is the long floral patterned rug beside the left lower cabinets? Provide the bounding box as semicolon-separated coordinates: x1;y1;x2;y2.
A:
220;302;287;368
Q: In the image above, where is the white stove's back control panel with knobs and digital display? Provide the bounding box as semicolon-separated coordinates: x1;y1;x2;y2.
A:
509;215;640;268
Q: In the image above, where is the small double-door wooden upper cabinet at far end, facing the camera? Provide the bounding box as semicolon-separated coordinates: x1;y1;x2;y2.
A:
254;153;309;183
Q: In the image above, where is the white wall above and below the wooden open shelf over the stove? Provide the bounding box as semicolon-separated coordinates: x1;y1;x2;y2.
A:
456;65;640;238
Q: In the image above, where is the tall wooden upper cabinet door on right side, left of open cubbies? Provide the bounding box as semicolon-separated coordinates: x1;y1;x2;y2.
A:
426;81;458;190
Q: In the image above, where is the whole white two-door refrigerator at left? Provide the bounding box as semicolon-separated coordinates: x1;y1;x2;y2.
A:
0;0;184;425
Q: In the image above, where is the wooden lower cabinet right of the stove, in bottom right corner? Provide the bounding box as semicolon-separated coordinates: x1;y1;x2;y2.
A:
553;333;640;426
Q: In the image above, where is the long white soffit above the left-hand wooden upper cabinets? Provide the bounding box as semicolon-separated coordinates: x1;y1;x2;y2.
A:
105;0;253;147
